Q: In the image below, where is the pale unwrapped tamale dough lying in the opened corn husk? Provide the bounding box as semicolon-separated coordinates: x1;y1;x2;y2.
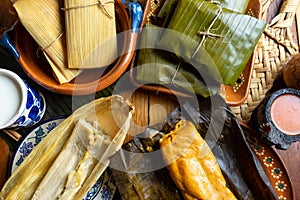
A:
33;119;111;199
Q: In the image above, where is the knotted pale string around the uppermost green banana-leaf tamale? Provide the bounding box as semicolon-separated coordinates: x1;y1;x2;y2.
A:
190;4;222;60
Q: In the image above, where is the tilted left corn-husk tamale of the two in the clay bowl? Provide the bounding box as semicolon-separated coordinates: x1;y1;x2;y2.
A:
13;0;80;84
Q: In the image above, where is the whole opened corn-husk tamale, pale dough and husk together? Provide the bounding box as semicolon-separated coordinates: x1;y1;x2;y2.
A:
0;95;134;200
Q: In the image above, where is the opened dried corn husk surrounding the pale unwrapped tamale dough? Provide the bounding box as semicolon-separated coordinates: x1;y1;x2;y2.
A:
0;95;134;200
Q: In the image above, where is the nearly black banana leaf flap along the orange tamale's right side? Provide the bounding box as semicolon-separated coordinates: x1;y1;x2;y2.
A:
164;95;277;199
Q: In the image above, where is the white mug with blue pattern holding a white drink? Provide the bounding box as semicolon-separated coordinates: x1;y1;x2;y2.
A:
0;68;46;129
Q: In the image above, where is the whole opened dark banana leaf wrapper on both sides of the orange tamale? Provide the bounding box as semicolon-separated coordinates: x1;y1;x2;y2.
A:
111;95;277;200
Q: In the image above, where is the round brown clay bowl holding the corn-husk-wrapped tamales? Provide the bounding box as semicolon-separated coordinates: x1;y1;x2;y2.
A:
14;1;137;95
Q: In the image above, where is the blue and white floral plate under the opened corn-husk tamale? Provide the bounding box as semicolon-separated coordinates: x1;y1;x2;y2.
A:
11;117;117;200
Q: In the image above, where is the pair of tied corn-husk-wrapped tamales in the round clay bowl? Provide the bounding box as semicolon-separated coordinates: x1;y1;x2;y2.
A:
11;0;117;84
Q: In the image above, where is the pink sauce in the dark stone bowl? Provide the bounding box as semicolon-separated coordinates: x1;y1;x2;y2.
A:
270;94;300;135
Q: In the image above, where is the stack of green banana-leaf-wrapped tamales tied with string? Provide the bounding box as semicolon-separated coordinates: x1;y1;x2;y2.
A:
136;0;266;97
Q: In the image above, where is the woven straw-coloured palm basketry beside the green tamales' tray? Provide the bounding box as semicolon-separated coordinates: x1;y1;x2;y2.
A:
231;0;300;123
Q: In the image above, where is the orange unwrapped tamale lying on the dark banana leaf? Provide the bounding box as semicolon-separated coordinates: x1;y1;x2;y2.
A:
160;120;235;200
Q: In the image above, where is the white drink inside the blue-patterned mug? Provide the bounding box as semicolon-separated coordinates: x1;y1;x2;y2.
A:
0;73;22;126
